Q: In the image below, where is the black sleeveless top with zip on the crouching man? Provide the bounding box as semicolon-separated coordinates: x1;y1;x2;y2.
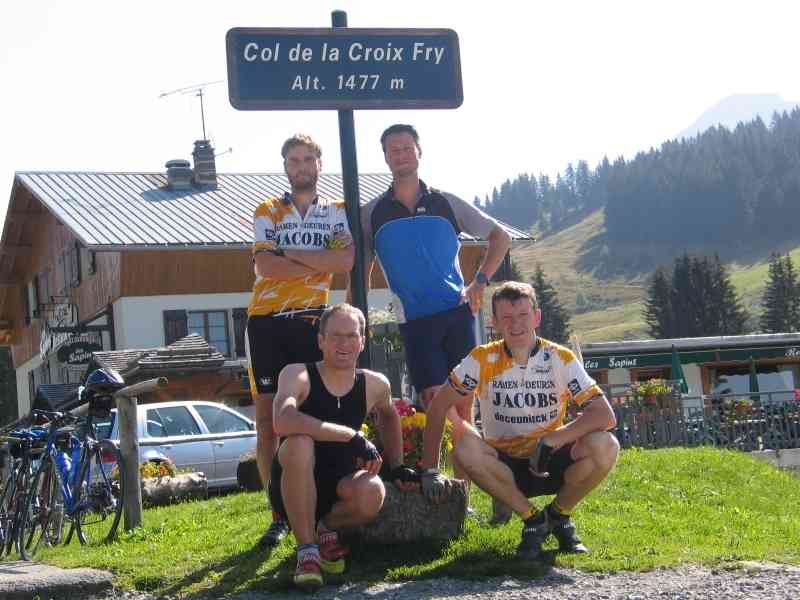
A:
299;363;367;461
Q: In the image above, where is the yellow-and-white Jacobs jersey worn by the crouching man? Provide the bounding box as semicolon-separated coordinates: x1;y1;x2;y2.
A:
448;338;603;458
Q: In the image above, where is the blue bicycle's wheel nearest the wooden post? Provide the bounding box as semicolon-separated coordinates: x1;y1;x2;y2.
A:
73;440;125;544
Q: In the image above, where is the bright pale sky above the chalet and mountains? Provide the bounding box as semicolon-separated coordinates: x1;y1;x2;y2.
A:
0;0;800;225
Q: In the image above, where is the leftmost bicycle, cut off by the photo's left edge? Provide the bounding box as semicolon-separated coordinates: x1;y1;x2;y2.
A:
0;427;47;556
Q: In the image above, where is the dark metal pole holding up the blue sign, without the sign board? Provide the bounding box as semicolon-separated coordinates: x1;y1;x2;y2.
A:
331;10;372;369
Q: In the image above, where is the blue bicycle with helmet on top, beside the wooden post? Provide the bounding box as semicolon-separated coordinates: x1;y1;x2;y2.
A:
18;369;125;560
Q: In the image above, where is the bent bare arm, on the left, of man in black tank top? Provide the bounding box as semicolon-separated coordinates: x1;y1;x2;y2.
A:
272;364;356;443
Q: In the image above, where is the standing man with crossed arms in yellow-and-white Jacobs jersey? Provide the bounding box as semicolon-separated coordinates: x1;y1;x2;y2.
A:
246;134;354;547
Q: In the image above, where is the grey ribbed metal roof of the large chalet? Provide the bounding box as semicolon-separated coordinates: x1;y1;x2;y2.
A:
9;171;533;250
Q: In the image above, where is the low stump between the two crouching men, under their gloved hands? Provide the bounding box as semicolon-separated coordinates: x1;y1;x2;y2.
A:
358;479;467;544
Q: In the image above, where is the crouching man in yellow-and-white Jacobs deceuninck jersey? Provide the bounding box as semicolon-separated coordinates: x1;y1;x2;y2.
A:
422;282;619;560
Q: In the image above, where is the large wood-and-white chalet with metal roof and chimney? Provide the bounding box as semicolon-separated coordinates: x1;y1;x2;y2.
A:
0;141;531;415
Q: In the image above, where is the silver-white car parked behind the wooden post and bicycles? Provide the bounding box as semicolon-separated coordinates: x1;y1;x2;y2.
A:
95;400;256;488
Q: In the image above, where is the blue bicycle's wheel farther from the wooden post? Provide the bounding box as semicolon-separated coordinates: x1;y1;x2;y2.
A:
17;455;60;560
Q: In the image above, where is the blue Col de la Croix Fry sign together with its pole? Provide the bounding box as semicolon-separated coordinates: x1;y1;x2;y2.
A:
225;17;464;367
